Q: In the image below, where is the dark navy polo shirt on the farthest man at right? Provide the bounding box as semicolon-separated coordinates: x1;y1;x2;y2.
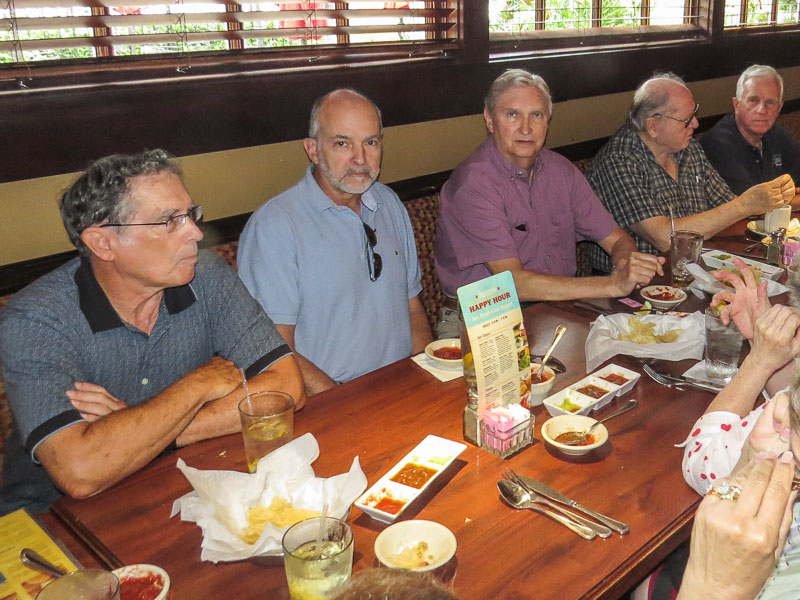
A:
700;113;800;195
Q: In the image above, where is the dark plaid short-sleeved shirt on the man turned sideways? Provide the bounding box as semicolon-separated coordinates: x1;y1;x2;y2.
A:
587;123;734;272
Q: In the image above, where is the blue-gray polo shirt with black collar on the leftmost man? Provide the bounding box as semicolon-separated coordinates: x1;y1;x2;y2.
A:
0;251;290;513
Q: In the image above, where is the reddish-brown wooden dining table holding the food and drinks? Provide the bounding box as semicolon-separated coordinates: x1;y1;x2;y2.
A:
45;218;780;600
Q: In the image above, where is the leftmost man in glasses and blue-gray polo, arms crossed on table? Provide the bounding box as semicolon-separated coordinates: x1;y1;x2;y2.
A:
0;150;305;514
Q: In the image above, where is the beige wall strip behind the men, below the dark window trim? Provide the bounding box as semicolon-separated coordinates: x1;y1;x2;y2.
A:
0;67;800;265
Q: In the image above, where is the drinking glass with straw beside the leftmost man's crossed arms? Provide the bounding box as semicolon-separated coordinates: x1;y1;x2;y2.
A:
239;392;294;473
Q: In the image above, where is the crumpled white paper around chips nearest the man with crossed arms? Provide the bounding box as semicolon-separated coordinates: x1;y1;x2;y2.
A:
170;433;367;562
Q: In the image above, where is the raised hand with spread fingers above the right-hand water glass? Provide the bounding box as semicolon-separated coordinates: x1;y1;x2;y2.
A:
711;258;770;340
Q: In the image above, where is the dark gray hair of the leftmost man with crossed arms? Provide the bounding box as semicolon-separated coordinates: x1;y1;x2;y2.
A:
59;150;180;258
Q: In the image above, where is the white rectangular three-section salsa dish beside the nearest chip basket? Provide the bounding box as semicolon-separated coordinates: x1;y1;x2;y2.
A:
355;435;467;523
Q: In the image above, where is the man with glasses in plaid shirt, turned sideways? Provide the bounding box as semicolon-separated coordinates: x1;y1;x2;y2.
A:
587;73;794;272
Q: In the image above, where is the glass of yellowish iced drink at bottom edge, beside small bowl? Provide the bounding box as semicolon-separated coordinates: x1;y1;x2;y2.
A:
283;517;353;600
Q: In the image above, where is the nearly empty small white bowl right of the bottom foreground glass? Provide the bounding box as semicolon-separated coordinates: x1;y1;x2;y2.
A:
375;520;458;571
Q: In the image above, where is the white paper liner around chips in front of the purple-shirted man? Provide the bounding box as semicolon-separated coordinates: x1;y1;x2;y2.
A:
585;312;706;373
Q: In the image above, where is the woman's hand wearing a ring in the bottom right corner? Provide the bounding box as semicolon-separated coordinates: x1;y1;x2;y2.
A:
678;451;797;600
